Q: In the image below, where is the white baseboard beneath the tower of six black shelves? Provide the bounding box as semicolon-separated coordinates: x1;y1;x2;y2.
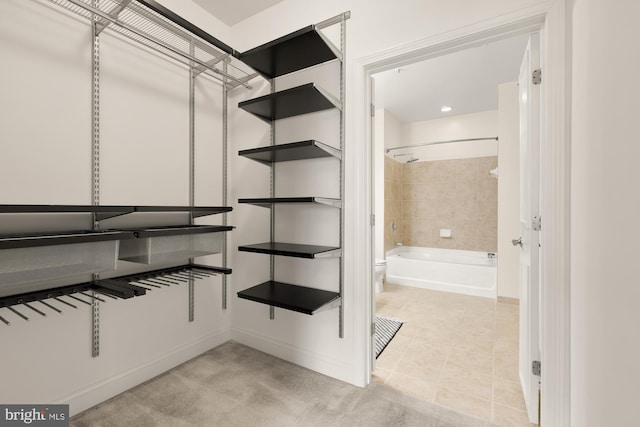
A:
231;329;357;385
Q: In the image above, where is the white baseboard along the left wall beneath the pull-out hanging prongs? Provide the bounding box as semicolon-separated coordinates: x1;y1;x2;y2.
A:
61;329;231;416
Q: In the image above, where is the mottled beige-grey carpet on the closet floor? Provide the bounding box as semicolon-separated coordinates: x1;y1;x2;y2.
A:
71;342;491;427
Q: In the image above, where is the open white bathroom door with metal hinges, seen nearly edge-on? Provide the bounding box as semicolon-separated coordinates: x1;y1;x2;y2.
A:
514;34;540;423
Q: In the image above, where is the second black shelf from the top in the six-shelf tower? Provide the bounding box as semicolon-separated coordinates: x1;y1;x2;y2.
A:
238;83;341;122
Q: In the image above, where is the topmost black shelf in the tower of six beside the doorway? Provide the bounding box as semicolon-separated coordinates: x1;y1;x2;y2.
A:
238;25;339;79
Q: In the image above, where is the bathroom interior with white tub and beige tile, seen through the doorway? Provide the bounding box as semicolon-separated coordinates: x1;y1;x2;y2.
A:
373;34;529;425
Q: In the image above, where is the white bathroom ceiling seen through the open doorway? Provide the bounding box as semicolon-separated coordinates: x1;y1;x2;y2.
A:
374;34;528;122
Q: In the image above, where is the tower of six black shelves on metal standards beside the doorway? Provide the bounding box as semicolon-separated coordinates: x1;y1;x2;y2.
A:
238;12;350;338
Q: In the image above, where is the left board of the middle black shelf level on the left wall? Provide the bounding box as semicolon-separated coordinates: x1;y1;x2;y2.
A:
0;230;135;249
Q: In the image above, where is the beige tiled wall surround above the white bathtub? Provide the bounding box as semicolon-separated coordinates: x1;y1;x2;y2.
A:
385;156;498;252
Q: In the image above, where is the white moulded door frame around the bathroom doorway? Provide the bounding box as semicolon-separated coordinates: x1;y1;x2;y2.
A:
351;0;571;426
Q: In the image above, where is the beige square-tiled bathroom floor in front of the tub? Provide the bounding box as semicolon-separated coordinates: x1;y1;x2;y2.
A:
374;284;533;427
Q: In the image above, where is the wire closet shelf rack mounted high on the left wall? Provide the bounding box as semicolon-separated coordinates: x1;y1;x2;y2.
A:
48;0;257;89
